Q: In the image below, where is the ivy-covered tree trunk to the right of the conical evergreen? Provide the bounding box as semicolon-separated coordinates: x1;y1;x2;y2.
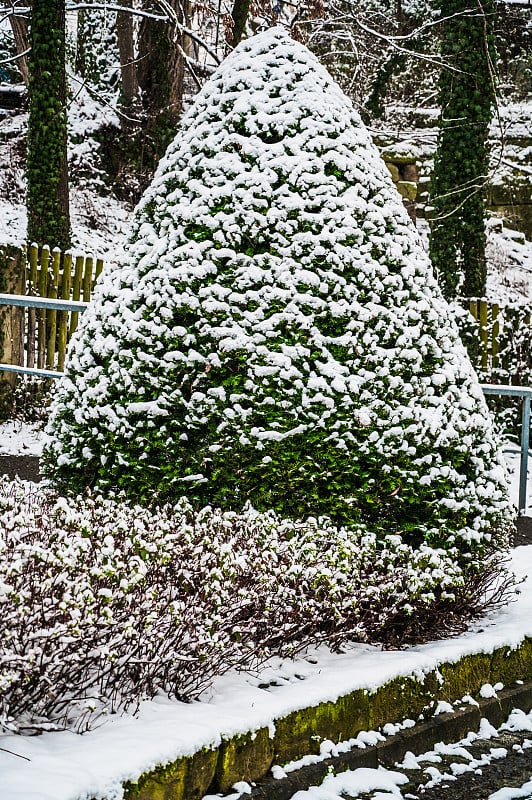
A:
430;0;496;299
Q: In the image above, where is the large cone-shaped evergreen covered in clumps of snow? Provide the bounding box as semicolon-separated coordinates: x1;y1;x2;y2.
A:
45;28;509;557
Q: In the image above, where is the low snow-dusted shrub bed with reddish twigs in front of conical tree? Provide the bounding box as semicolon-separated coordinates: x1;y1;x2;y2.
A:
0;479;508;730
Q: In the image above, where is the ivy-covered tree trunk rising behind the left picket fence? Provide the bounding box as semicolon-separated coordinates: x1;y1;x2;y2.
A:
26;0;70;250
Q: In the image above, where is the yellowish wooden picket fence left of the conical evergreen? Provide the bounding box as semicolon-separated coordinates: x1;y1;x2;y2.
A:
0;245;103;382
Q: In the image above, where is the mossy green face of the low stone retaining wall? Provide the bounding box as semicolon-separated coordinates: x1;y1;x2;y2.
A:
120;639;532;800
